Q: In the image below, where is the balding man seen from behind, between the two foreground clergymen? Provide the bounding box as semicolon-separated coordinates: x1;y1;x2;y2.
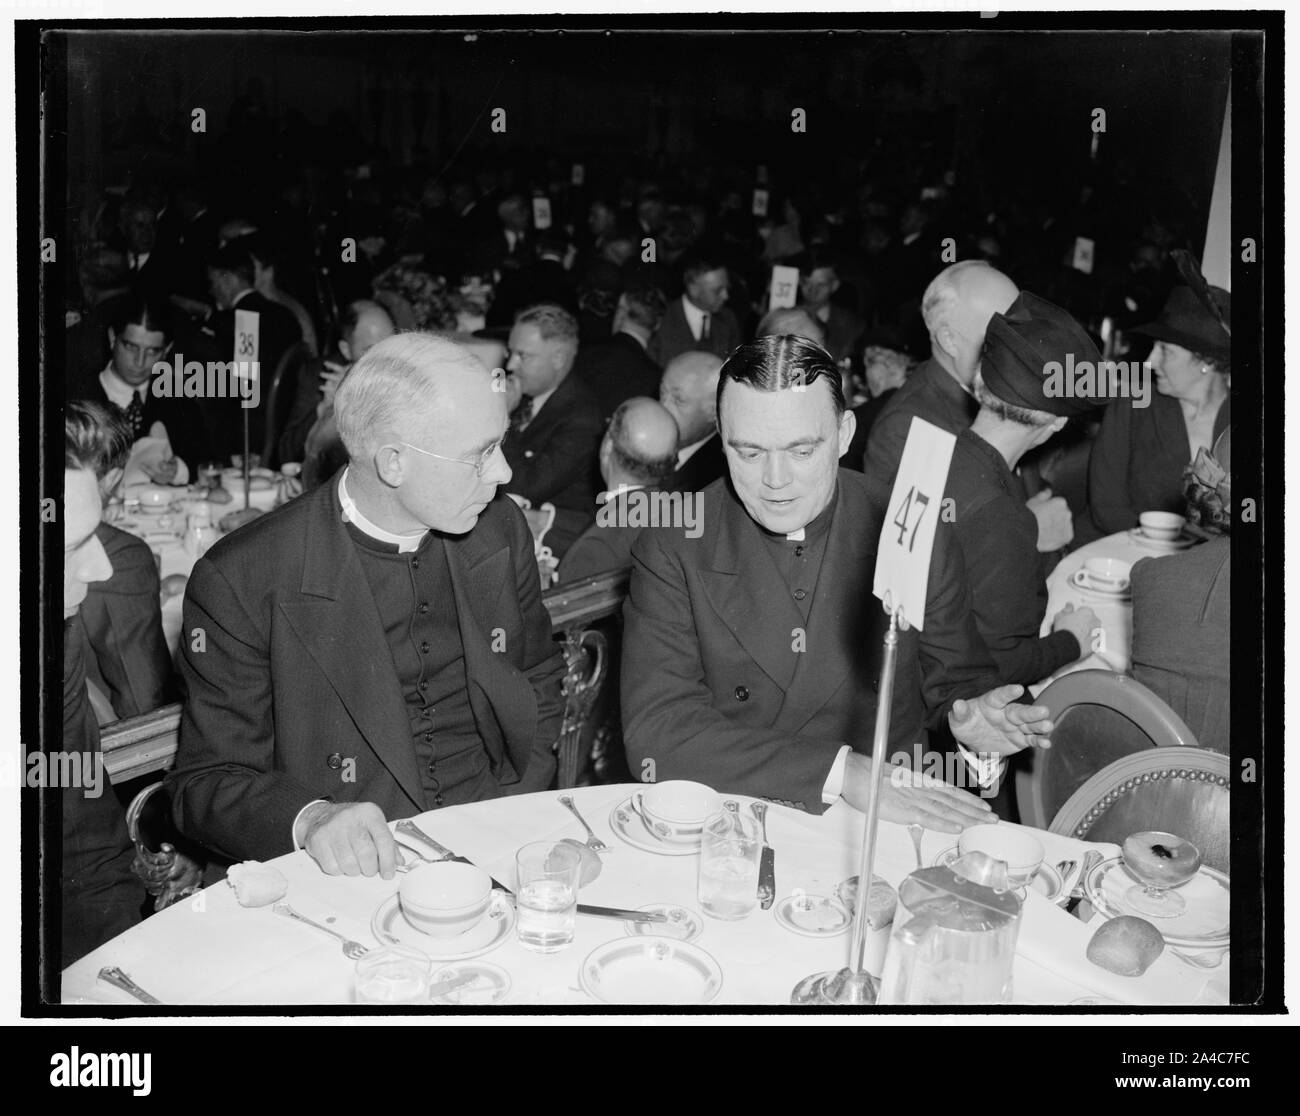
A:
559;398;683;583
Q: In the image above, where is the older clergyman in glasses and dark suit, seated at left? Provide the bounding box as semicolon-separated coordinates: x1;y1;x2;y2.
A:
168;334;564;879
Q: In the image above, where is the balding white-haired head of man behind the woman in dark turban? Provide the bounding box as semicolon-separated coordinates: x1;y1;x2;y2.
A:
920;260;1021;388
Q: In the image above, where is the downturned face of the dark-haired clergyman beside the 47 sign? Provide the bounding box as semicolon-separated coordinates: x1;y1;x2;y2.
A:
718;380;854;535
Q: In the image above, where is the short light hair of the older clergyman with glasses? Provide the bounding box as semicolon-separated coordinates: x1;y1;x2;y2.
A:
334;333;488;462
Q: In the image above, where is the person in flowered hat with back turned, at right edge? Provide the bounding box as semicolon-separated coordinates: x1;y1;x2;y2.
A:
1132;431;1232;752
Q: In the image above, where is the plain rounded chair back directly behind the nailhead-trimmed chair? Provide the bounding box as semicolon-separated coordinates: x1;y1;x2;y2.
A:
1013;670;1197;829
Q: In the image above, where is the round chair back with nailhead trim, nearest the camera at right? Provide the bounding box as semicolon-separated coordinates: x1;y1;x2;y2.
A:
1050;747;1231;871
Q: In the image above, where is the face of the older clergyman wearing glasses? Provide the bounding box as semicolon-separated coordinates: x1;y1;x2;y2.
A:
397;368;511;535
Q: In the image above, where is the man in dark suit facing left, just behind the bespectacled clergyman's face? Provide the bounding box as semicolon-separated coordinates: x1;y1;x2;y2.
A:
502;303;605;558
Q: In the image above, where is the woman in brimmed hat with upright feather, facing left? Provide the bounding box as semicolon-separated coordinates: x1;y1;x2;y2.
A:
1088;252;1231;535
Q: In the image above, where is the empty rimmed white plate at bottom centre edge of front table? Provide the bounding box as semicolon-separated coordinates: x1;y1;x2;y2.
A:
579;938;723;1005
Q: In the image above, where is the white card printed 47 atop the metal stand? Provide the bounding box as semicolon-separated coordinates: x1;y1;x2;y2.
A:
871;419;957;628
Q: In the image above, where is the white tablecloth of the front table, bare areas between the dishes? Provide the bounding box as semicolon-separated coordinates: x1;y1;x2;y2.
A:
62;786;1229;1011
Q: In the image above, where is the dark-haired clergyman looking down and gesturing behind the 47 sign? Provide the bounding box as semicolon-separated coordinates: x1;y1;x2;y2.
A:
623;336;1050;832
